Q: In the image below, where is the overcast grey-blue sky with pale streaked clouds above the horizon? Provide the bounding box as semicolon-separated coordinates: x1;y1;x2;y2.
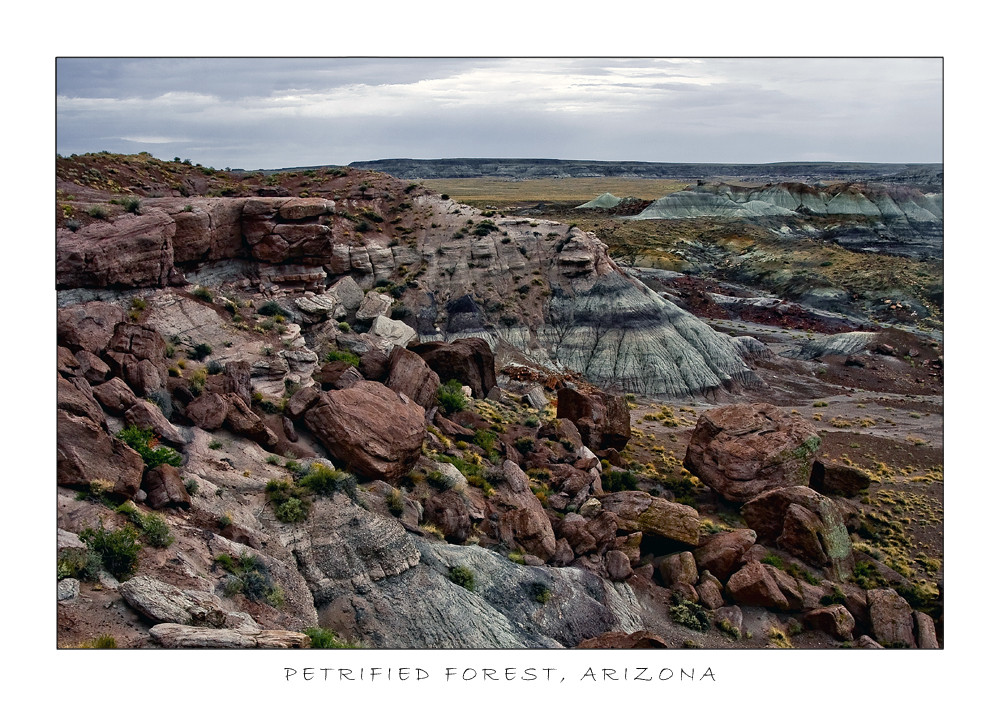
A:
56;58;942;169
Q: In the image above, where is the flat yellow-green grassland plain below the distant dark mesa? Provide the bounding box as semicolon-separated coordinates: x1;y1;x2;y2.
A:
422;177;690;208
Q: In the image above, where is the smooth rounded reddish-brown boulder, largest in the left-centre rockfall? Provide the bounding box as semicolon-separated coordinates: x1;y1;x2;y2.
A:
304;381;426;483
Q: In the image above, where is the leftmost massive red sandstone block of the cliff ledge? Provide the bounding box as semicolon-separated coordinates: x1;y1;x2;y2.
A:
56;210;176;288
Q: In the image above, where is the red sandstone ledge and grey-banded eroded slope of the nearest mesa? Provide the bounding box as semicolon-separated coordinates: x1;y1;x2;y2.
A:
56;188;759;397
